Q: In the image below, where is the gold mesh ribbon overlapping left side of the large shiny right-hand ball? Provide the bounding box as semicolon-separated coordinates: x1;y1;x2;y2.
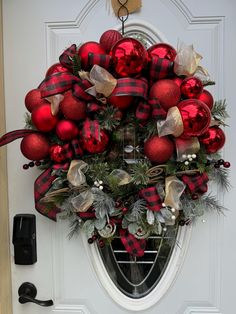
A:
157;106;184;137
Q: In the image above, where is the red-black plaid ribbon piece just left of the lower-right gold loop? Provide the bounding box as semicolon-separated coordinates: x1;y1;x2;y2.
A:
139;186;162;212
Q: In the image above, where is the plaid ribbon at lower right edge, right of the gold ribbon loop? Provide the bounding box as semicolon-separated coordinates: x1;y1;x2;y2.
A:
181;172;209;194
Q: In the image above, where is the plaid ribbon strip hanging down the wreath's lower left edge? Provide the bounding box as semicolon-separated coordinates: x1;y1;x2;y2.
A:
34;168;60;220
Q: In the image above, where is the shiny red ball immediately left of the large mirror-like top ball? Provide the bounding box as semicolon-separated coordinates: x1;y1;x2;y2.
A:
78;41;106;70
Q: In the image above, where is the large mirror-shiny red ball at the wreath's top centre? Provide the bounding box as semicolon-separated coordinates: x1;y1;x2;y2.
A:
110;38;147;77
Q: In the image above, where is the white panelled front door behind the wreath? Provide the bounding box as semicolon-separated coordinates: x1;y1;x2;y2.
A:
3;0;236;314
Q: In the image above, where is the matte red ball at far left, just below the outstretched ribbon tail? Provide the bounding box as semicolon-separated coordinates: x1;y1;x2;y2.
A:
20;133;50;160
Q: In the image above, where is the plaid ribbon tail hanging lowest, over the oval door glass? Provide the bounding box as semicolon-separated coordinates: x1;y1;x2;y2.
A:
120;229;146;257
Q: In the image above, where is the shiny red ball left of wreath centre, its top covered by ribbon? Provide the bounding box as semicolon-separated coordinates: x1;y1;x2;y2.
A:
81;130;109;154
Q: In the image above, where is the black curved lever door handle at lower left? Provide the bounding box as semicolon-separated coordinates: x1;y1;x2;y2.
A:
18;282;53;306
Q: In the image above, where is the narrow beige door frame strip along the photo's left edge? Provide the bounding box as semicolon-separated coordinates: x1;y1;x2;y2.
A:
0;0;12;314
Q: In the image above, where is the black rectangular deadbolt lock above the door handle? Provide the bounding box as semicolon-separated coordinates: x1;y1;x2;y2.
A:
12;214;37;265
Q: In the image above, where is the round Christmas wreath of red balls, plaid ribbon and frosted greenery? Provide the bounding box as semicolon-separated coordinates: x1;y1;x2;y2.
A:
0;30;230;256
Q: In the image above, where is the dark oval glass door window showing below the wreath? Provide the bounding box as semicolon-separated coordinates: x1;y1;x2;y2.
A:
99;227;178;299
